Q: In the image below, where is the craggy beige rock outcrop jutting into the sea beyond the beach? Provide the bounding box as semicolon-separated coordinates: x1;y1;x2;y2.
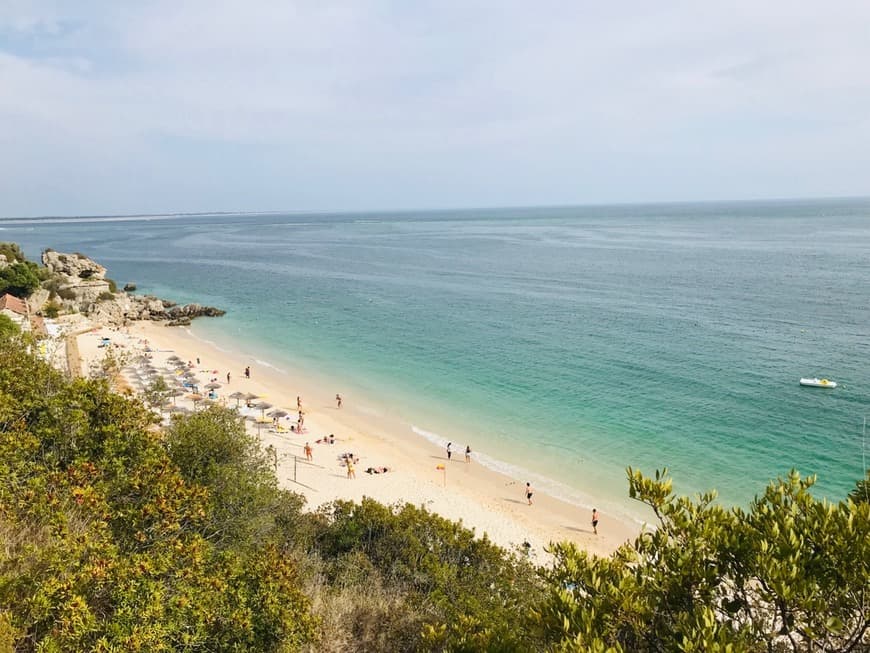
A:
38;250;225;325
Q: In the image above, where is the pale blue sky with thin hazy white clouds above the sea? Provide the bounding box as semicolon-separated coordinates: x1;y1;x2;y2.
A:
0;0;870;217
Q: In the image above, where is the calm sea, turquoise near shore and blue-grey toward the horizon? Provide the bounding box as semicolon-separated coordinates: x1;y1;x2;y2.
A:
0;200;870;510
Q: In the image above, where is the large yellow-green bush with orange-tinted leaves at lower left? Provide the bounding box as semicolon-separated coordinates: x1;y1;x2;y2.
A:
0;341;317;651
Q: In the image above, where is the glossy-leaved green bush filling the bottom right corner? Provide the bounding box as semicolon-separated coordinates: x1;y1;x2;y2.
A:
540;470;870;652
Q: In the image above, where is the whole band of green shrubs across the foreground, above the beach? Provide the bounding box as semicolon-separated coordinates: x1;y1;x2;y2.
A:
0;334;870;652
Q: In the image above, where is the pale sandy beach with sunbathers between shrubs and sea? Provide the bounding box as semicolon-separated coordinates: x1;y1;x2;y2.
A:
78;322;640;563
